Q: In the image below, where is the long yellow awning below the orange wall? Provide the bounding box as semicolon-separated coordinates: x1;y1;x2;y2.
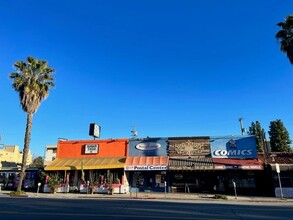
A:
45;157;126;171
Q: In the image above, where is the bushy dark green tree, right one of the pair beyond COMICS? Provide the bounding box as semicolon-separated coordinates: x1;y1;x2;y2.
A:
269;119;292;152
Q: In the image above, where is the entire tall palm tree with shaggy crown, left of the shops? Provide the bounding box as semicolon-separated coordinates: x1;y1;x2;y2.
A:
10;57;54;191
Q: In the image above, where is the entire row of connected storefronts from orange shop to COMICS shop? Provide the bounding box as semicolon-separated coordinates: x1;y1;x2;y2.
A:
45;136;264;193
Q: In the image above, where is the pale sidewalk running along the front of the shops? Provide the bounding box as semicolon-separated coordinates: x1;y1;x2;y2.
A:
0;190;293;204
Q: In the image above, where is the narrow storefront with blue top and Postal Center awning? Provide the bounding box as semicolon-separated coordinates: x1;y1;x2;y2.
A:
124;138;169;192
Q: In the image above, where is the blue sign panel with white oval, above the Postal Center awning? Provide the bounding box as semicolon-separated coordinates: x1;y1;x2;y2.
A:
128;138;167;156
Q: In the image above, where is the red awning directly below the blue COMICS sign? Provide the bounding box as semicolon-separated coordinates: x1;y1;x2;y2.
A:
213;158;263;170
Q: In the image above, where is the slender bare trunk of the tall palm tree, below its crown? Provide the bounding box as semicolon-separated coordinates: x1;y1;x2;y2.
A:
17;113;33;191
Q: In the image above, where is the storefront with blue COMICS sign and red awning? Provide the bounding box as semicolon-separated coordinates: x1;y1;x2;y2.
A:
210;135;264;194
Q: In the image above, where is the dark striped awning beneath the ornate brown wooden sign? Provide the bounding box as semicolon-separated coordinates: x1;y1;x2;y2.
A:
169;157;214;170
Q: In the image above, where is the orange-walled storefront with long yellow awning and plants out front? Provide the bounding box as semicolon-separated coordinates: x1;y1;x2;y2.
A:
44;139;128;193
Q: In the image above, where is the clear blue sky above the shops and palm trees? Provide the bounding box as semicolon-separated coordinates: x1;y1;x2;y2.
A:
0;0;293;156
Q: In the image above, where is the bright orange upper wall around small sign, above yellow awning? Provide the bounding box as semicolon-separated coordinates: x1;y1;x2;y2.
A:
56;139;128;158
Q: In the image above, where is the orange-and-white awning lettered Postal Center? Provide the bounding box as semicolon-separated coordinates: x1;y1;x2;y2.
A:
124;156;169;171
